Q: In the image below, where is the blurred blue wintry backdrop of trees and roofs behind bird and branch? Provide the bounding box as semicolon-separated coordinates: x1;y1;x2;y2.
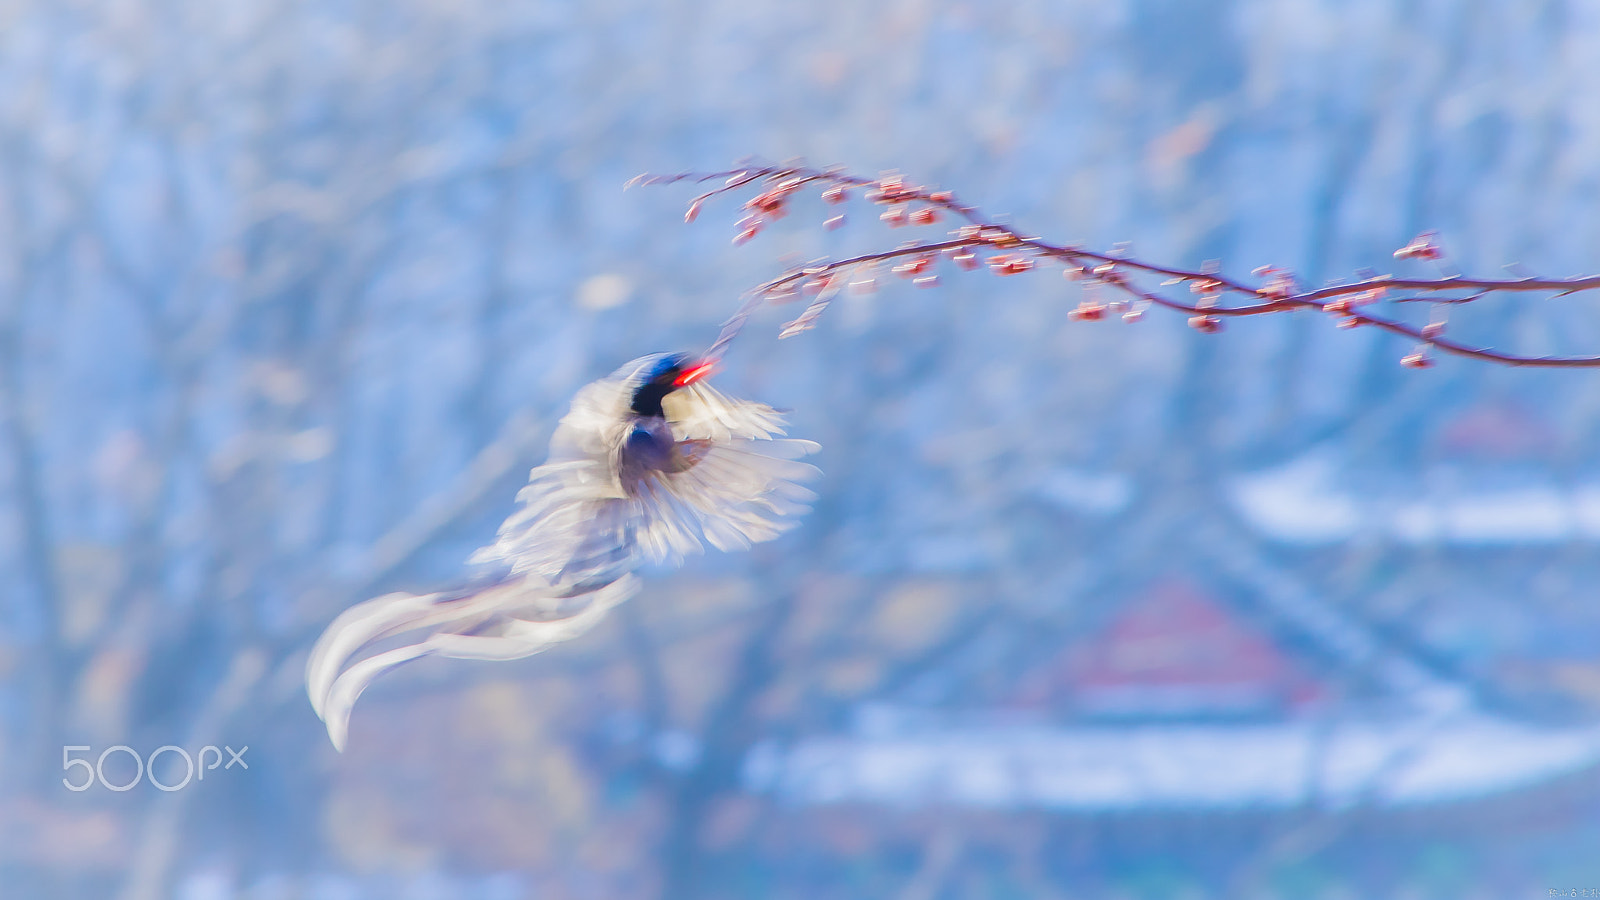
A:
0;0;1600;900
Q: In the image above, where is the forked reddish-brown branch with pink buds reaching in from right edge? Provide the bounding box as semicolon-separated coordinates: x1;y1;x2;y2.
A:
630;165;1600;368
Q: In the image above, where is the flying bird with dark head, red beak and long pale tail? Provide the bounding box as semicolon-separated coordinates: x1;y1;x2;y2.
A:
306;354;818;751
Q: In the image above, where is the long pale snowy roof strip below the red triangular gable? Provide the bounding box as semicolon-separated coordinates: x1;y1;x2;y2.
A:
744;713;1600;812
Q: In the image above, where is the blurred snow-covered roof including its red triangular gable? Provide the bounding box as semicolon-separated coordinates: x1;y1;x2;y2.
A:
746;581;1600;814
